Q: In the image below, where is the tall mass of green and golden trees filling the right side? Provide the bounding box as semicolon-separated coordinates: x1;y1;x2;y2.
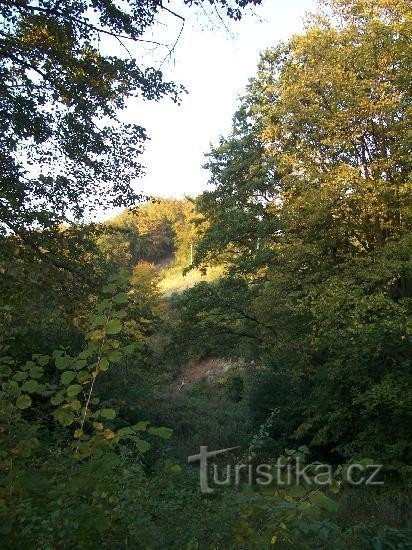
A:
193;0;412;464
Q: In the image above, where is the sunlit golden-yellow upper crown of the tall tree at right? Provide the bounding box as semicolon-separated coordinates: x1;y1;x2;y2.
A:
252;0;412;254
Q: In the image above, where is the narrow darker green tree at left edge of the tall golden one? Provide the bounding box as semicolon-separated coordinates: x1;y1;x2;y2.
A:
196;99;279;275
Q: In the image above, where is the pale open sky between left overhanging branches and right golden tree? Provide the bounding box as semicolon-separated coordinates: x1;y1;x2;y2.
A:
100;0;315;217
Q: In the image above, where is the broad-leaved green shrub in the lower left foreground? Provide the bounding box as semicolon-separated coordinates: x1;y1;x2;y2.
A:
0;274;172;547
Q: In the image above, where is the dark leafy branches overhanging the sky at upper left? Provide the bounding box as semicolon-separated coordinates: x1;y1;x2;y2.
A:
0;0;260;233
